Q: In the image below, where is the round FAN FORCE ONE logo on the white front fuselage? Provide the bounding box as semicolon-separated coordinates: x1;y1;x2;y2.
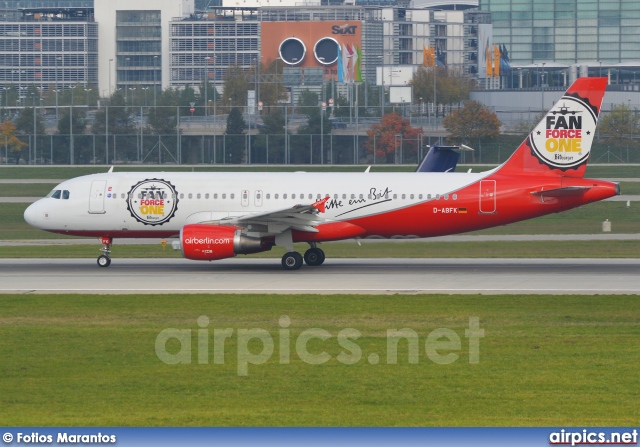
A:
127;179;178;225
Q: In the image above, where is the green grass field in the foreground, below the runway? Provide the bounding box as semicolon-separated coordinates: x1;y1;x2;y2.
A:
0;295;640;426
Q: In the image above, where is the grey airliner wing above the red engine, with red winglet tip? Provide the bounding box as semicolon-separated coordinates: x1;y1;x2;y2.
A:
216;197;329;233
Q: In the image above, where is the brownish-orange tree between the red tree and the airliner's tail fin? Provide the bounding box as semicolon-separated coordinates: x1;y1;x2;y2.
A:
442;101;501;145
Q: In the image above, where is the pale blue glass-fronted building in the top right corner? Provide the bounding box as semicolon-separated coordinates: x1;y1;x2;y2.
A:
480;0;640;66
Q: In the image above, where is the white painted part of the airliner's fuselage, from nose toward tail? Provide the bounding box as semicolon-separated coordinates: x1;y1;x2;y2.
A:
25;171;493;237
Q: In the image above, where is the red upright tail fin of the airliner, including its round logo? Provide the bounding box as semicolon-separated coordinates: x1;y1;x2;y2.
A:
500;78;607;177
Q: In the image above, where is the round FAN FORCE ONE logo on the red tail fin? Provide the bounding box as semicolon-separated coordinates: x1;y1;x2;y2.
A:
529;96;597;169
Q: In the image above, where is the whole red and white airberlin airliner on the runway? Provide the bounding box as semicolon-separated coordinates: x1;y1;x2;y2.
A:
24;78;620;270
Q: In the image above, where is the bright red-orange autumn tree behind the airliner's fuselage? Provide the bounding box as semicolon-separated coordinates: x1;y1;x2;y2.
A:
365;112;419;163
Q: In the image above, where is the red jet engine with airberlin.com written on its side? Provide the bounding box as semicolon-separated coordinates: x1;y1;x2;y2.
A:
180;224;273;261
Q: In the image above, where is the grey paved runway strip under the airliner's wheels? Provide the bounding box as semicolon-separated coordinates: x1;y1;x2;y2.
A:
0;258;640;294
